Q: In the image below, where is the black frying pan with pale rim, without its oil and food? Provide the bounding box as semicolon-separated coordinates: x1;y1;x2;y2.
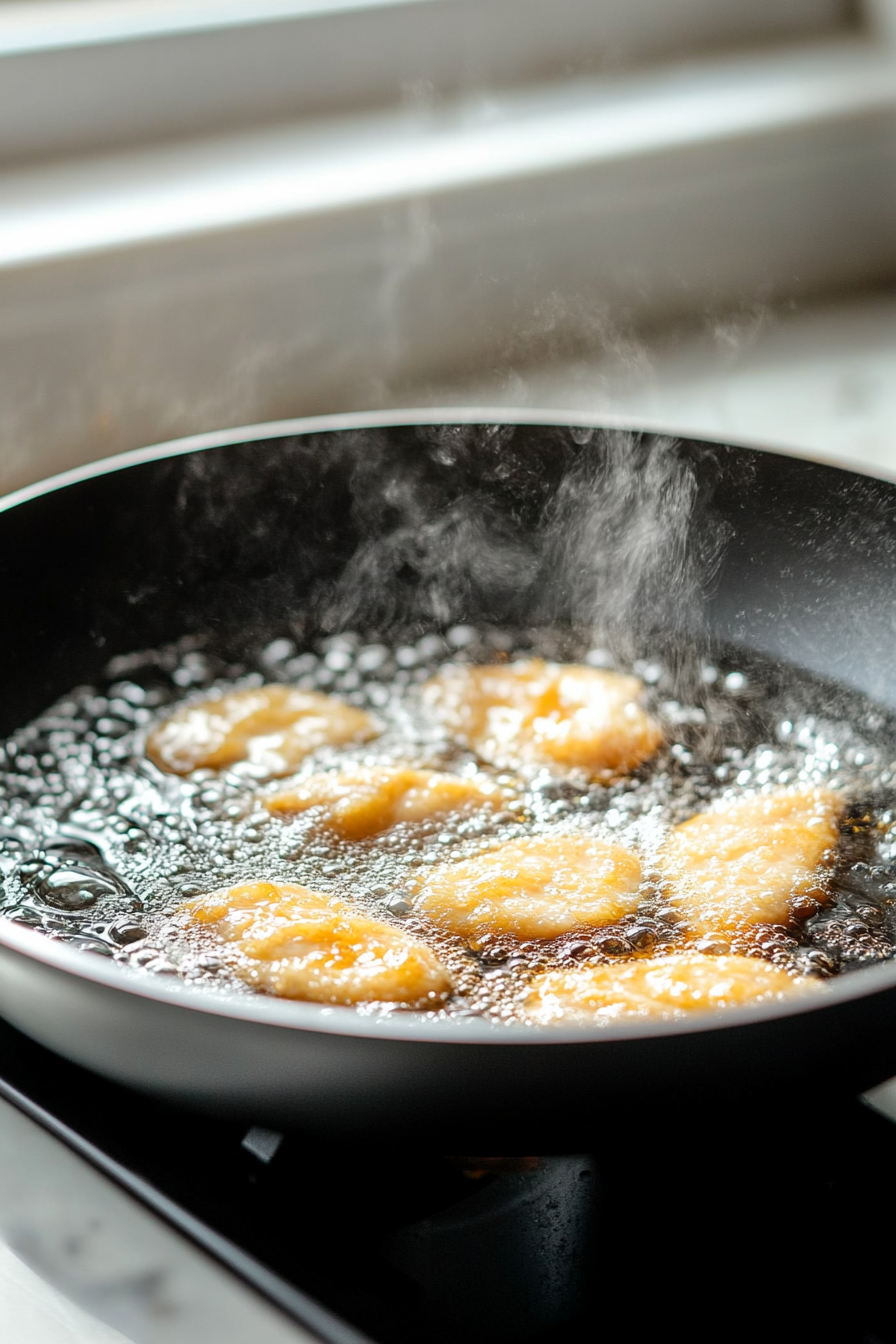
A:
0;411;896;1152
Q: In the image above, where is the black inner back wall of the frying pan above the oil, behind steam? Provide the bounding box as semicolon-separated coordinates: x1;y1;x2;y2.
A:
0;425;896;734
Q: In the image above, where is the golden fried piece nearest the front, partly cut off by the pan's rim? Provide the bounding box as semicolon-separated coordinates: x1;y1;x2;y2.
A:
524;952;819;1024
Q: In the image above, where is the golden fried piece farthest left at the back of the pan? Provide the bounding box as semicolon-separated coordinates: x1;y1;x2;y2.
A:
146;685;376;778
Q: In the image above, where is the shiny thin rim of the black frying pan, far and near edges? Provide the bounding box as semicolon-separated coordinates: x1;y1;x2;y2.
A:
0;406;896;1047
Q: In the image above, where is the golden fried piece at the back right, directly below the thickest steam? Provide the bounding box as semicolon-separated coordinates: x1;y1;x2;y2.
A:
423;659;662;780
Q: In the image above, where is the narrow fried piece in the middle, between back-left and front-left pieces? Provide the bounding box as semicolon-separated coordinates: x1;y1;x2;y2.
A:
262;766;506;840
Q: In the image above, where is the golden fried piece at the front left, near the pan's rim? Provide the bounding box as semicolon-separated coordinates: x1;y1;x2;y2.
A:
181;882;451;1007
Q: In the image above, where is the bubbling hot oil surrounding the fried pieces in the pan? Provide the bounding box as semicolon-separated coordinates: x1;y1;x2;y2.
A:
0;626;896;1020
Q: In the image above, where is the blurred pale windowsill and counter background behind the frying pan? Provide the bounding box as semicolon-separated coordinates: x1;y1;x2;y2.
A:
0;0;896;489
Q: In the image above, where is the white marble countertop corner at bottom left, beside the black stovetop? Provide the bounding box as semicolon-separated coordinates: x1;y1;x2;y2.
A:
0;1101;314;1344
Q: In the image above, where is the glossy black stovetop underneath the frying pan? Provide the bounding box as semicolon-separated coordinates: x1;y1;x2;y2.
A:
0;1023;896;1344
